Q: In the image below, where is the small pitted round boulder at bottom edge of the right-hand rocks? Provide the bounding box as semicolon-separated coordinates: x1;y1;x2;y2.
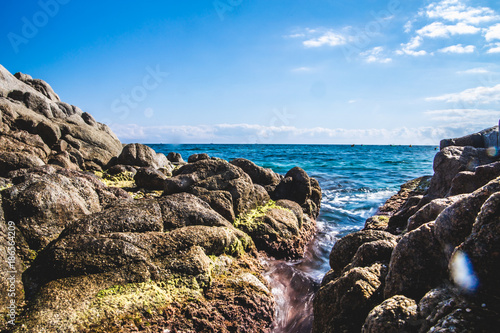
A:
361;295;419;333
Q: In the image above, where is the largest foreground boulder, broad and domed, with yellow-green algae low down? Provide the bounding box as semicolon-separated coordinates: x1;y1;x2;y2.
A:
15;194;274;332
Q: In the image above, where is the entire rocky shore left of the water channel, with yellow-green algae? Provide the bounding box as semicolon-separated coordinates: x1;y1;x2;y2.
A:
0;66;321;332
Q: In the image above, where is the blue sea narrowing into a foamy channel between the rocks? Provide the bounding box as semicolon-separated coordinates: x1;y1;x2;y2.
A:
149;144;439;333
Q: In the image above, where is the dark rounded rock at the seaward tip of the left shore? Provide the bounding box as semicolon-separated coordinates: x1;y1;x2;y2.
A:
271;167;321;219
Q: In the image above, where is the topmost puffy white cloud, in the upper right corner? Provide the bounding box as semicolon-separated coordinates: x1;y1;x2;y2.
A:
425;0;500;25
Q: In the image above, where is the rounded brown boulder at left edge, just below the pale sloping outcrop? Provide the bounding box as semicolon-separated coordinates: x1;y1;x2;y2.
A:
2;166;131;250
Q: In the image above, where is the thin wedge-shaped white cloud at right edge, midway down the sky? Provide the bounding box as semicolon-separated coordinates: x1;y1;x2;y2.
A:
426;84;500;104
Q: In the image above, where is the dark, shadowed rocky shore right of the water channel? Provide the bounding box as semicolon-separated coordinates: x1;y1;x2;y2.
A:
313;127;500;333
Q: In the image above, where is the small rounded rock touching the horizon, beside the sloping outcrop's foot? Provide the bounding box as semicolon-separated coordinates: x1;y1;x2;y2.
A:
116;143;173;169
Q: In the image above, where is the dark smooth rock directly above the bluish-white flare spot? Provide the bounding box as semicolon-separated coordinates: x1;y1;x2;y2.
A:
435;179;500;259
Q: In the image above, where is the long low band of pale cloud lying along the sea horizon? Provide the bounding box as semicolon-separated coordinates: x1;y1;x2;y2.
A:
111;120;482;144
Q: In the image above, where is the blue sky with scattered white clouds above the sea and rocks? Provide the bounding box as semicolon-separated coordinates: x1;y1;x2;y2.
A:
0;0;500;144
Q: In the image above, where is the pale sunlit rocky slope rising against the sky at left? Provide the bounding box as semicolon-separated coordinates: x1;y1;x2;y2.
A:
0;65;122;171
